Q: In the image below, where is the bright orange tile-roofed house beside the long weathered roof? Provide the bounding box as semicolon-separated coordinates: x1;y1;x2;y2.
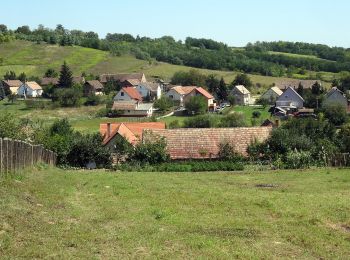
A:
100;122;165;146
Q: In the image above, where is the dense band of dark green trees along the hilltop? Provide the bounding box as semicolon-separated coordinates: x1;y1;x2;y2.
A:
0;24;350;77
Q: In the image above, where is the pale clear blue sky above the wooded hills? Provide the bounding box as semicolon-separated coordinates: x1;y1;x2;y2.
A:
0;0;350;47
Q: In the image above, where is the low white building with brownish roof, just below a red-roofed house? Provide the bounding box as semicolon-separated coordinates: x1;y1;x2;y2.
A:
112;100;153;117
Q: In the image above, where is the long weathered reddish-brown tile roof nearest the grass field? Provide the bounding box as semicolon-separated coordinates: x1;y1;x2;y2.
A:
143;127;272;160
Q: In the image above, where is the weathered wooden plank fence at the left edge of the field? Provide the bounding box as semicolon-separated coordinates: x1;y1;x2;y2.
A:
0;138;57;173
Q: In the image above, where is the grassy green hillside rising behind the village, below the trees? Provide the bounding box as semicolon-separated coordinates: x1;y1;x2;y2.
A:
0;41;333;85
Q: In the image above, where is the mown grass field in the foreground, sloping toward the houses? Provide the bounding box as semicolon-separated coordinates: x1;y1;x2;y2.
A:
0;168;350;259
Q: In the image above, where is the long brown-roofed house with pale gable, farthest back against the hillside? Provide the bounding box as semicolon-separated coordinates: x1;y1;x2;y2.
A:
100;73;147;86
